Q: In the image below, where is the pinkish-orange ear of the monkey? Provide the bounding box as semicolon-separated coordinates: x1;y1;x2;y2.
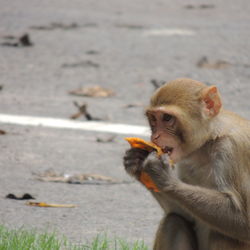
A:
202;86;222;116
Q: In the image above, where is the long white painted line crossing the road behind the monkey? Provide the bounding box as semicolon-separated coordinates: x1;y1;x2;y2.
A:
0;114;150;136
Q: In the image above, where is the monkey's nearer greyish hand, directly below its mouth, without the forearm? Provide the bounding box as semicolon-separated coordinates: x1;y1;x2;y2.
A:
142;152;178;191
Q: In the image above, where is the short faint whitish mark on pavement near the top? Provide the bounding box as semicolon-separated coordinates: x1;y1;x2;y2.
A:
143;28;195;36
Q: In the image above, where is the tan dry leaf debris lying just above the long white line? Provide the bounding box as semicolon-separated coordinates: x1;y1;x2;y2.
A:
69;85;115;97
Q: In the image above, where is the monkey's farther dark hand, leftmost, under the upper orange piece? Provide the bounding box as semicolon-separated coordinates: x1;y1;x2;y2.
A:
123;148;149;179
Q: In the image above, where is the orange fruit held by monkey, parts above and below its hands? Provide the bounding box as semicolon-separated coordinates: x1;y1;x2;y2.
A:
125;137;166;192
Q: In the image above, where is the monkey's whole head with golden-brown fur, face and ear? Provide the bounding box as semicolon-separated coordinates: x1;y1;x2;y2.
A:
146;79;222;162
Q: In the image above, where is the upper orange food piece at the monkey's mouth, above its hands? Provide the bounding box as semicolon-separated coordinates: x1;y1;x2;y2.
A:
125;137;163;156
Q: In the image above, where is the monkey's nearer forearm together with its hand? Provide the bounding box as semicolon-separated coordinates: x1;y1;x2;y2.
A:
144;155;250;241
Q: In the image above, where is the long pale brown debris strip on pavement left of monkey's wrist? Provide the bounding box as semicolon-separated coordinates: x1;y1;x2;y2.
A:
35;170;131;185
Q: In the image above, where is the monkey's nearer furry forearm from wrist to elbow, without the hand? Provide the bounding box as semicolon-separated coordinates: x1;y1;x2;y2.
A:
166;182;250;241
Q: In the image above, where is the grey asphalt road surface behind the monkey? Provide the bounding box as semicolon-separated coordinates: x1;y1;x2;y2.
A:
0;0;250;245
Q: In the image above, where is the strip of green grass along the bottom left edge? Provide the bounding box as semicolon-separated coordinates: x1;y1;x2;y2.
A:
0;225;148;250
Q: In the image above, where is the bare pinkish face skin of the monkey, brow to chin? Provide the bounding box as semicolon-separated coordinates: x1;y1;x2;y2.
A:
147;108;183;162
